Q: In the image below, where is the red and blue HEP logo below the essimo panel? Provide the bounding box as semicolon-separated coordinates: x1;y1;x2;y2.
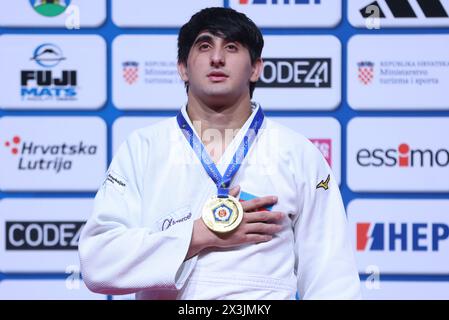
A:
356;222;449;251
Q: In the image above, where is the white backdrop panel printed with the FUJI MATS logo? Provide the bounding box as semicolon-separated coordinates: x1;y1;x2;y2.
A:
0;35;106;110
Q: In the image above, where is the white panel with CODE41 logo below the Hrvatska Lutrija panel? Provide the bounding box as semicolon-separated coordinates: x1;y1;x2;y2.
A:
0;199;93;273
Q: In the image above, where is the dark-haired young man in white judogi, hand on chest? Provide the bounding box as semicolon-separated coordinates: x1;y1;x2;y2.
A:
79;8;360;299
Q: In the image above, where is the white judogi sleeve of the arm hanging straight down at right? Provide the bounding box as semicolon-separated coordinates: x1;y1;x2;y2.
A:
294;141;360;299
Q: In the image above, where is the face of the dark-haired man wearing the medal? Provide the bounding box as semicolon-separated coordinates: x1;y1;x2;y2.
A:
178;31;262;105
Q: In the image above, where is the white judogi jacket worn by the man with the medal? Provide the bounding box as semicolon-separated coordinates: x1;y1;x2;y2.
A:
79;103;360;299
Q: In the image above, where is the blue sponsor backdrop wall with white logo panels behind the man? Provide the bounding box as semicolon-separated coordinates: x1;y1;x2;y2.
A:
0;0;449;299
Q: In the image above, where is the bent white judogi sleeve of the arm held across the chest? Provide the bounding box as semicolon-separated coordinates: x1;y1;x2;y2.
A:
79;132;192;294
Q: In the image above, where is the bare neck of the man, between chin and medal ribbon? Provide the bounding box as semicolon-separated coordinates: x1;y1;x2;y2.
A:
187;96;251;140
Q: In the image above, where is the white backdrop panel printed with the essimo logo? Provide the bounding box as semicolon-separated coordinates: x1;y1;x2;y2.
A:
347;117;449;192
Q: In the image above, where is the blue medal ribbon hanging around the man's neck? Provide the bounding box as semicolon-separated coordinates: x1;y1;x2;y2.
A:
176;107;264;198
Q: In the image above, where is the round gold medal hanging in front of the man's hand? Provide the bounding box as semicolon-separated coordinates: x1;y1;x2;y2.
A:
202;195;243;233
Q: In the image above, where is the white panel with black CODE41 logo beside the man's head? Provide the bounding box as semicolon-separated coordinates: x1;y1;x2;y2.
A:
254;35;341;110
